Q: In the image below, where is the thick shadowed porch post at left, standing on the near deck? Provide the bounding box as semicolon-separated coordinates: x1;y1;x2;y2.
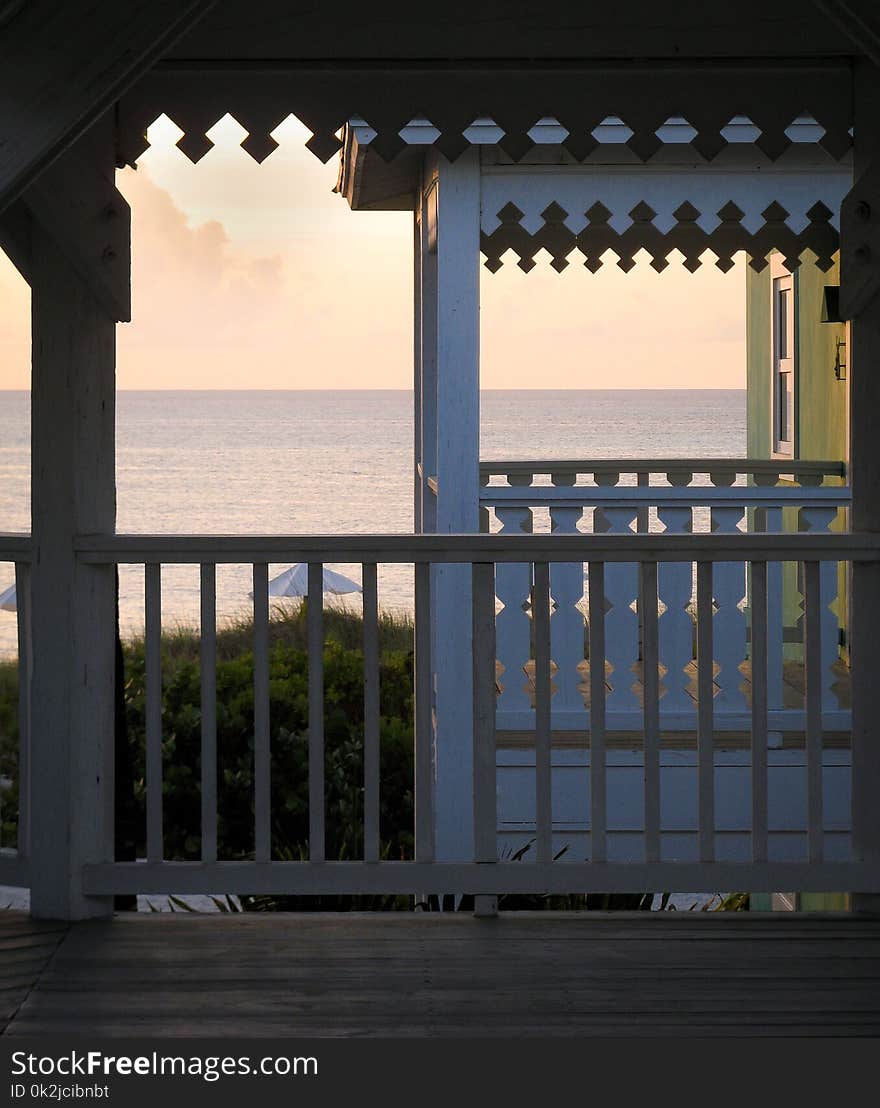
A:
25;124;121;919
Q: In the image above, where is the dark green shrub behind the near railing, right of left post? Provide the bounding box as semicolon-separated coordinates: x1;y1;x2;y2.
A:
124;605;413;860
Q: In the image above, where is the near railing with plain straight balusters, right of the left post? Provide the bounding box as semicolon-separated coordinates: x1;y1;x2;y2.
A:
44;533;880;895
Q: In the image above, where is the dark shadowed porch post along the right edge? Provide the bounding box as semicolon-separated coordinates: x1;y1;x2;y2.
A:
840;61;880;912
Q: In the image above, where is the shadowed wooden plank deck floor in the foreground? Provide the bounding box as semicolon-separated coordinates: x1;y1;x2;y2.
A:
0;912;880;1037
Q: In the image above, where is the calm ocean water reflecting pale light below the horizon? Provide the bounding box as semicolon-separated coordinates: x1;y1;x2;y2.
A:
0;390;746;656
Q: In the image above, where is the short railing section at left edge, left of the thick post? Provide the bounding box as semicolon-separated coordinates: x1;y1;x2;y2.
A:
0;534;31;886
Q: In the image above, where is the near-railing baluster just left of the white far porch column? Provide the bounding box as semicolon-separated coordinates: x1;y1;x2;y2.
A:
415;562;434;862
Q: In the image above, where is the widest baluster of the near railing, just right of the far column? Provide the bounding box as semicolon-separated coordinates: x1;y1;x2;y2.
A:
472;562;498;862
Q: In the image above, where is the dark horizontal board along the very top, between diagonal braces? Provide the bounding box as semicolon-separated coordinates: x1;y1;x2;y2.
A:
157;0;851;60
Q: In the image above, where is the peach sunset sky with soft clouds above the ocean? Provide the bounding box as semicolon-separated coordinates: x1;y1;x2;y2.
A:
0;116;745;389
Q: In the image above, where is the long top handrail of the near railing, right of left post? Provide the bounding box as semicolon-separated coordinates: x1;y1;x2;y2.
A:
75;532;880;565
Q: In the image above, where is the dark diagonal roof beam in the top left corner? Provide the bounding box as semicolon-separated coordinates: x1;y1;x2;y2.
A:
0;0;215;211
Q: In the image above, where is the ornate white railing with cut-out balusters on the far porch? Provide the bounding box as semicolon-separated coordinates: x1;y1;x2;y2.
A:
480;459;850;731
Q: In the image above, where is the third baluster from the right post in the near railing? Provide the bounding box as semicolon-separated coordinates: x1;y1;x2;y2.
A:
697;562;715;862
